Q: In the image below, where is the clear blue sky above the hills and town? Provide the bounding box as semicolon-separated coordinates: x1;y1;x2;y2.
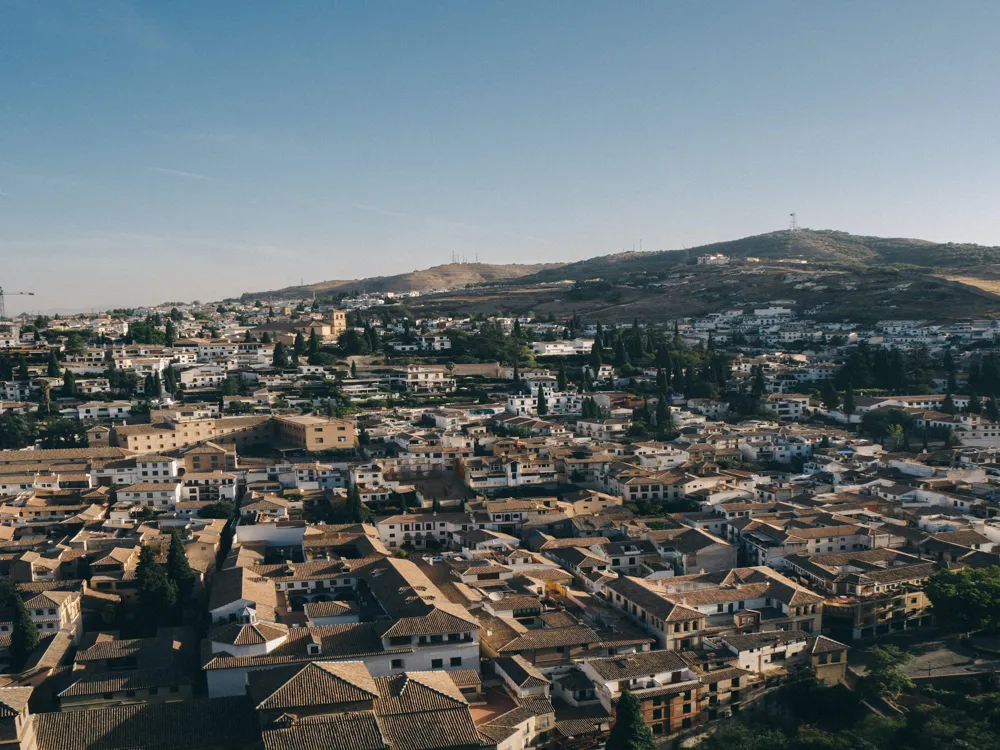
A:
0;0;1000;310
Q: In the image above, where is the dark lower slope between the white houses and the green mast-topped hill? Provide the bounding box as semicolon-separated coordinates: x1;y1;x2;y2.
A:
408;261;1000;323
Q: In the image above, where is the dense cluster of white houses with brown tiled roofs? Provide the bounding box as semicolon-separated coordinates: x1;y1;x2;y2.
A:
0;306;1000;750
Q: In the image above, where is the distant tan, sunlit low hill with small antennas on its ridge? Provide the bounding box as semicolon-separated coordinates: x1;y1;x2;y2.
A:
243;263;559;299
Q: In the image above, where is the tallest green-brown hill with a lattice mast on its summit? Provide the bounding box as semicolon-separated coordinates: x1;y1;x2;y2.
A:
519;229;1000;283
